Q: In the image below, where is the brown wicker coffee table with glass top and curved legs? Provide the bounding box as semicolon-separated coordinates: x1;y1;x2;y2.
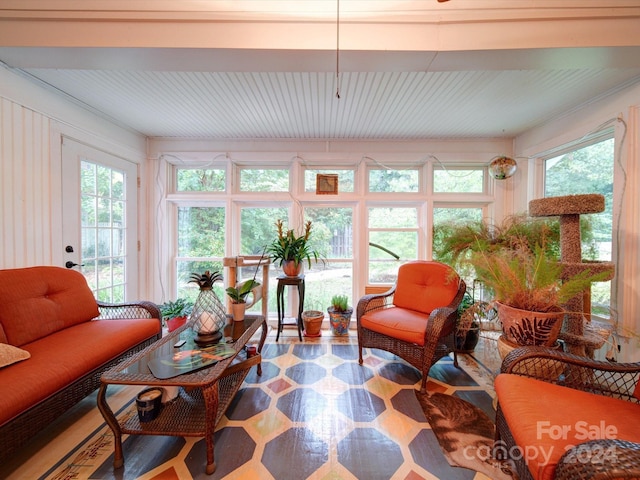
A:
98;315;267;474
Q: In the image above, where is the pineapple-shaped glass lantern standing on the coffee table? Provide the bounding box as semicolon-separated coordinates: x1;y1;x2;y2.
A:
189;270;227;346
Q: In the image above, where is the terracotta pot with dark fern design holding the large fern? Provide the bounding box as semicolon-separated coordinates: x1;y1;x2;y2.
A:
496;302;564;347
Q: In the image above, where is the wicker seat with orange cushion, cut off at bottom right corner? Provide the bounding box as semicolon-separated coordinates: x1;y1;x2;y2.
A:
494;347;640;480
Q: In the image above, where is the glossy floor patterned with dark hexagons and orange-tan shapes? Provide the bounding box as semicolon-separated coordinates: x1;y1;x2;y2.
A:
0;330;504;480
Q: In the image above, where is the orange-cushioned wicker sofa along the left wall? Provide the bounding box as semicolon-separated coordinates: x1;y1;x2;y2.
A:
0;266;162;460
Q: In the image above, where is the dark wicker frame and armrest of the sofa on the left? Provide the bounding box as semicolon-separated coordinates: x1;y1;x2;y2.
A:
0;301;162;461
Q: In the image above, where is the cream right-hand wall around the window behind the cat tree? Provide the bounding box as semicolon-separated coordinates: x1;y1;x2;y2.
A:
514;85;640;362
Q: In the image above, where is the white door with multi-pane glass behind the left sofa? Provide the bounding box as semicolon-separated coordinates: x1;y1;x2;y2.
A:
62;138;138;302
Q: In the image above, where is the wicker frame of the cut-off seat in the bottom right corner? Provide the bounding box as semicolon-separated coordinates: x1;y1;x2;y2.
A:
496;347;640;480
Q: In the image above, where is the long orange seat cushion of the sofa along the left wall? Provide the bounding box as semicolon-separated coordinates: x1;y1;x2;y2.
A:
0;318;160;425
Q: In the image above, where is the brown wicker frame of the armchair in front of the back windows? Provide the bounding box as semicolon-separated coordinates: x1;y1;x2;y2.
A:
356;279;467;393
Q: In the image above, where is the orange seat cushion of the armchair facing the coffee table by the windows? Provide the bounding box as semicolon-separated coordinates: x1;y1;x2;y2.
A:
360;307;429;345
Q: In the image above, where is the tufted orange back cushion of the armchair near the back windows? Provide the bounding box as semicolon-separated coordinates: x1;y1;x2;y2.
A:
393;260;460;314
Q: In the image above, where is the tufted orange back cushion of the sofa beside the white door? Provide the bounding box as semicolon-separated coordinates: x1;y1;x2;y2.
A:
0;267;99;347
